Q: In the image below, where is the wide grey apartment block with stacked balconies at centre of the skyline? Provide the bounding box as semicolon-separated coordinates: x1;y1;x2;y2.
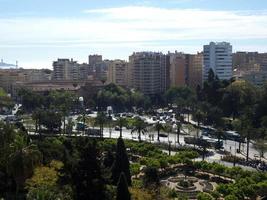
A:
129;52;169;95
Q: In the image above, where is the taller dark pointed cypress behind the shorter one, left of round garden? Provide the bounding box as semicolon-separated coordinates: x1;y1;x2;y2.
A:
112;137;132;185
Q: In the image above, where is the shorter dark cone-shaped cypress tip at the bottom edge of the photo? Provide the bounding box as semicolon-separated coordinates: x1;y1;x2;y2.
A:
116;172;131;200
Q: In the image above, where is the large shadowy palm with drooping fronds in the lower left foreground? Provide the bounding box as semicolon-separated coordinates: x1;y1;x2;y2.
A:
7;134;42;193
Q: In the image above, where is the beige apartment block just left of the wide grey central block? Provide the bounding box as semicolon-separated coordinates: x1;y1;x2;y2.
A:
107;60;128;87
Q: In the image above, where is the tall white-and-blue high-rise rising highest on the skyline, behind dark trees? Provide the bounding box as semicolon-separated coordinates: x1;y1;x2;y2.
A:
203;42;233;80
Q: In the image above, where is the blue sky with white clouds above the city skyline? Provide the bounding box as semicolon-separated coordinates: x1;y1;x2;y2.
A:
0;0;267;68
